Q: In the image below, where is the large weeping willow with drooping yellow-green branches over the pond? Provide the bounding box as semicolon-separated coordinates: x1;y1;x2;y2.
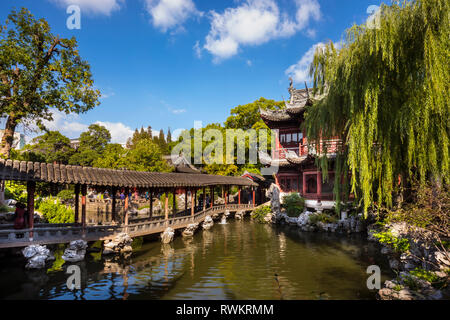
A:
305;0;450;218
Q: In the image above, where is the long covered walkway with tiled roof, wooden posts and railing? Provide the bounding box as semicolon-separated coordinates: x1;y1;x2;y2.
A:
0;160;258;248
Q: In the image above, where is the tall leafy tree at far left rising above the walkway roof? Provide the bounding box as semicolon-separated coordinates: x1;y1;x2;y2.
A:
0;8;100;158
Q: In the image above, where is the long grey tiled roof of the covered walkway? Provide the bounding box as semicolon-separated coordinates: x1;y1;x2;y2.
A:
0;159;256;188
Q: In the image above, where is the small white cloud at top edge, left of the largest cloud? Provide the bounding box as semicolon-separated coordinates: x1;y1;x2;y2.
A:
145;0;202;32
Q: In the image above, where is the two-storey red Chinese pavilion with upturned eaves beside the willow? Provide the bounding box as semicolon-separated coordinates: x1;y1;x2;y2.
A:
260;80;341;209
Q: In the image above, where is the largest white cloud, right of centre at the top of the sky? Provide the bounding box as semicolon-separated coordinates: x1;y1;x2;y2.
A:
204;0;321;62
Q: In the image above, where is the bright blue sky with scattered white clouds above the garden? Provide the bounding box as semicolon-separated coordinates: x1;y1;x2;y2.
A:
0;0;381;143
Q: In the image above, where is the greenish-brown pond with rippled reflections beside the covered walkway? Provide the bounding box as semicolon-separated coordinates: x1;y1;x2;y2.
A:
0;218;393;300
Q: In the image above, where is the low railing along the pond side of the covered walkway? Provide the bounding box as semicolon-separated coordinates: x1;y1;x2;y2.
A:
0;204;253;248
